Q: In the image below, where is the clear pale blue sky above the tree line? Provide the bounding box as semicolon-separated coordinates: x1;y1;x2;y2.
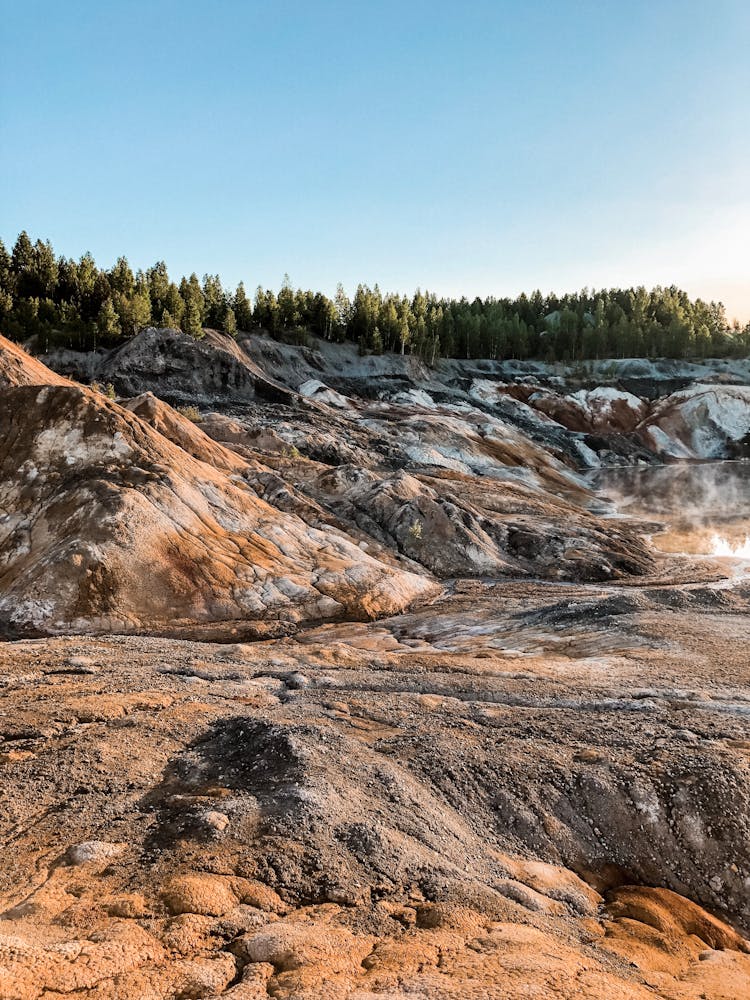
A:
0;0;750;322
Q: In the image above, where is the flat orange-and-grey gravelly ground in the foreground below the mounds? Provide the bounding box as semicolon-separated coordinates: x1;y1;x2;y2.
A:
0;564;750;1000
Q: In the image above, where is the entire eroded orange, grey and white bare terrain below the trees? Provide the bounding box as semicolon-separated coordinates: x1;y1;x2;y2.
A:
0;331;750;1000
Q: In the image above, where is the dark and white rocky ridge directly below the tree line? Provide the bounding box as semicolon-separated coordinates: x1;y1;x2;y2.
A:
46;330;750;468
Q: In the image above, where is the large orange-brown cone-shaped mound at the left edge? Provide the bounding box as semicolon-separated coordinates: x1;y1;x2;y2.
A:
0;385;431;632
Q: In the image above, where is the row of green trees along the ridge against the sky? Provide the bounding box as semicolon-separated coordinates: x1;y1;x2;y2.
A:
0;232;750;363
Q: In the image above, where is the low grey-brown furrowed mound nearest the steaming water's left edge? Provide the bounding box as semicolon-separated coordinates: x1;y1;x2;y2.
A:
307;466;653;580
